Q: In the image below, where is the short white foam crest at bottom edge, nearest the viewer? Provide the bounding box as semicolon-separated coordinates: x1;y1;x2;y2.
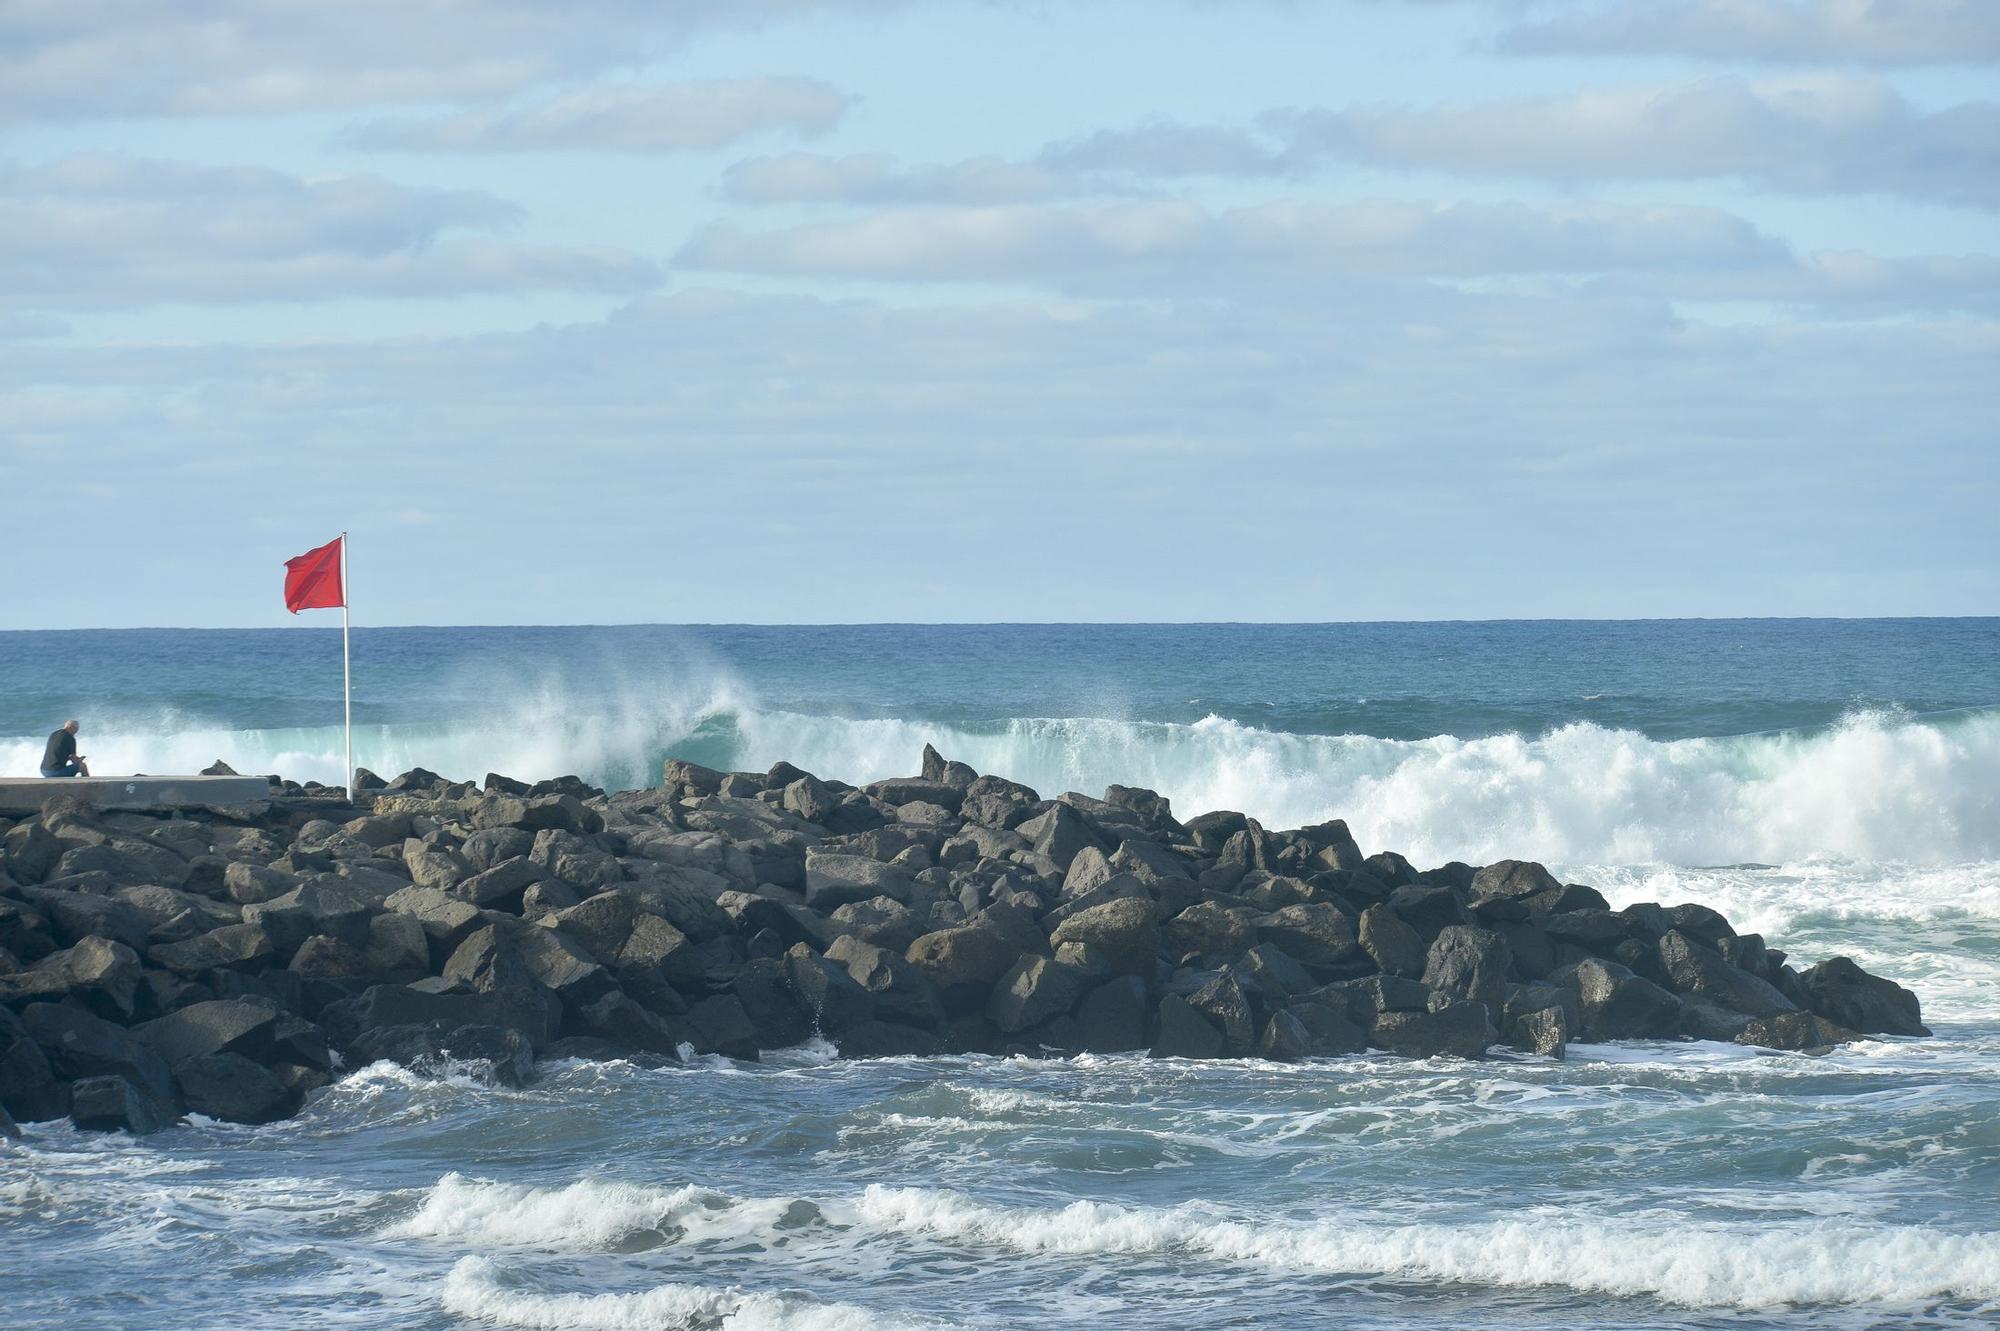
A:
442;1257;940;1331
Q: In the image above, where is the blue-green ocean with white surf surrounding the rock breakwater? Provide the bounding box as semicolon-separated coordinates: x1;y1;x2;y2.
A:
0;620;2000;1331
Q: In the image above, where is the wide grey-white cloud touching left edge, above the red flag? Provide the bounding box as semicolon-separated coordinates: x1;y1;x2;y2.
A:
0;156;658;310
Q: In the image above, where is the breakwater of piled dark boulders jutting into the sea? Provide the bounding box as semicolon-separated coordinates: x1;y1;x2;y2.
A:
0;749;1930;1133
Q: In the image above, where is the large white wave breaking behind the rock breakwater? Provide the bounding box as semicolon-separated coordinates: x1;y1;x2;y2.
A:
0;691;2000;865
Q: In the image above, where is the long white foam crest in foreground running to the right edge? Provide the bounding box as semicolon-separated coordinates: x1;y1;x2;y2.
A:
860;1185;2000;1309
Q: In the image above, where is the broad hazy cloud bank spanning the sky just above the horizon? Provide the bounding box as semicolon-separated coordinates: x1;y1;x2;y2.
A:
0;284;2000;626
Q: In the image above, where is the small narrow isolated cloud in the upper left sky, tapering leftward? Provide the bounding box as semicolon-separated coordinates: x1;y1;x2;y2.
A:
350;78;854;152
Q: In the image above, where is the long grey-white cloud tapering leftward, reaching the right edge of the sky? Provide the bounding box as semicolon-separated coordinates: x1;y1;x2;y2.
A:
1270;74;2000;208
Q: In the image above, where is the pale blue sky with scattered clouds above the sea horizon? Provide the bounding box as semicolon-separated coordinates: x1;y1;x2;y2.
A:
0;0;2000;630
